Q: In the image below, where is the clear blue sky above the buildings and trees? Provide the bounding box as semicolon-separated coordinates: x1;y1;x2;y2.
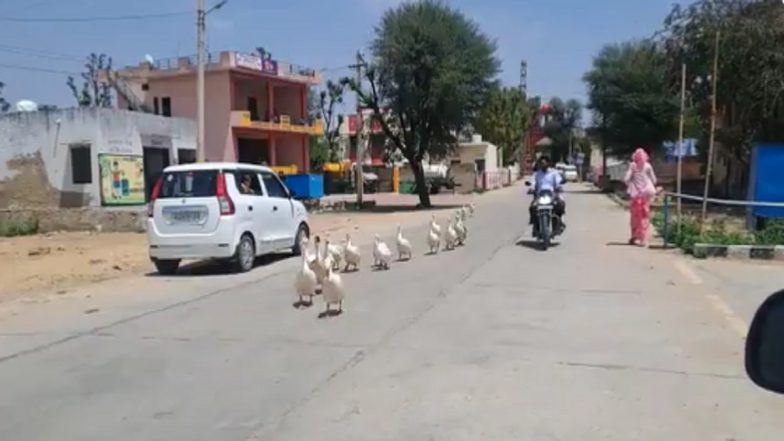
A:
0;0;674;111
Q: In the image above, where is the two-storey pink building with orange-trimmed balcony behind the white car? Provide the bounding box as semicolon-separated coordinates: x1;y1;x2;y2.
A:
116;51;322;172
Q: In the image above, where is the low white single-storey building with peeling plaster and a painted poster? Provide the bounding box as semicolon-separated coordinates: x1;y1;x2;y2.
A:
0;108;196;231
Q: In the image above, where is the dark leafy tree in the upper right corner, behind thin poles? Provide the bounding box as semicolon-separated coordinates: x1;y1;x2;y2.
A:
661;0;784;162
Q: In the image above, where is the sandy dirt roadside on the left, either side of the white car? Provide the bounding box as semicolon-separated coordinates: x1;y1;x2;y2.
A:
0;194;478;303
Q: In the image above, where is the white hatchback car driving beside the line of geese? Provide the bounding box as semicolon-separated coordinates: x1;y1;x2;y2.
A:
147;163;310;274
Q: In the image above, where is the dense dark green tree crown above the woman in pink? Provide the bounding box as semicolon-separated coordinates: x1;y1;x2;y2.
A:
583;41;679;156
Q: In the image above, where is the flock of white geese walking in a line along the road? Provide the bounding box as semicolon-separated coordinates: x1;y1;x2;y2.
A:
294;204;475;316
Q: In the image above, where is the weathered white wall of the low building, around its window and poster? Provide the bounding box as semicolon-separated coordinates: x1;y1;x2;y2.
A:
0;108;195;230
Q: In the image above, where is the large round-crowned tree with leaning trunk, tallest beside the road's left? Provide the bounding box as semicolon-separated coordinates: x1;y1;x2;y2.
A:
343;0;499;207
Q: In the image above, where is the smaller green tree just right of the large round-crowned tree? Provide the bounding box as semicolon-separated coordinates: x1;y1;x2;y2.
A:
476;87;529;164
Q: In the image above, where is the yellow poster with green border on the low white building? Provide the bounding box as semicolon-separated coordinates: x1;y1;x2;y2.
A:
98;155;145;206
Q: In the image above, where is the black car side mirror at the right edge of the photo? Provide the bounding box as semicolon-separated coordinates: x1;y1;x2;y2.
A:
746;290;784;394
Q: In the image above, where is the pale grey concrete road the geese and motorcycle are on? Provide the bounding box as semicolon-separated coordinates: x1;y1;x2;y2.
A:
0;183;784;441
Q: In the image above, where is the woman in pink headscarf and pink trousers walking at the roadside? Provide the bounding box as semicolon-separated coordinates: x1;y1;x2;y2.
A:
624;149;656;246
